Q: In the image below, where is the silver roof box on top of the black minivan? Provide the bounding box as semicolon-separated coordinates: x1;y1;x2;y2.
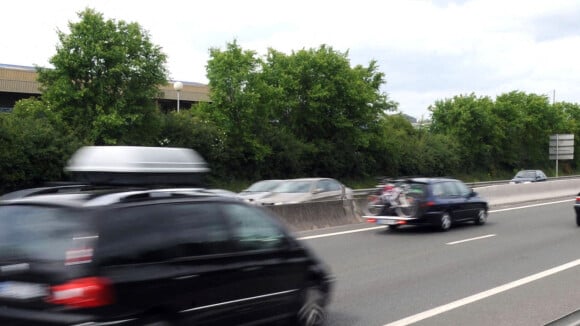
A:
65;146;209;186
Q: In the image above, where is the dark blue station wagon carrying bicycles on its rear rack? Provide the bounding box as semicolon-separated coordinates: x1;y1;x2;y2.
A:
364;178;488;231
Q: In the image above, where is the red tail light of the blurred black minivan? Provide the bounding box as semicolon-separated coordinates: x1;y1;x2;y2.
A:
47;277;113;308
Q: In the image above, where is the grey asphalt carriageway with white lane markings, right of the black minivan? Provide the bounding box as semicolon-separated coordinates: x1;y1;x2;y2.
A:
297;199;580;326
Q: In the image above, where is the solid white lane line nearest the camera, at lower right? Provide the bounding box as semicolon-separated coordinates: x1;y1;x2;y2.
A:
384;259;580;326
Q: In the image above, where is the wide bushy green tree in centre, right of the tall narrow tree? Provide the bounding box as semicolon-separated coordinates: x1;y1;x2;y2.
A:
262;45;396;177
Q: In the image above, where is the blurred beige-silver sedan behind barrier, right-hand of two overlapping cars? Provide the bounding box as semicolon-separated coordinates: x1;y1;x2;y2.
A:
256;178;353;205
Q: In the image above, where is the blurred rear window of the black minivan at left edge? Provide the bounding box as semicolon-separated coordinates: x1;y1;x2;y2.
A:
0;205;91;262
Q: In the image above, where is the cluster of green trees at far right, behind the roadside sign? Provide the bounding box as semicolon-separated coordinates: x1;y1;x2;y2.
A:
431;91;578;175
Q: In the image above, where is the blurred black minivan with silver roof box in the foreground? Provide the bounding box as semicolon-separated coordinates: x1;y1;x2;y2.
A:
0;146;332;325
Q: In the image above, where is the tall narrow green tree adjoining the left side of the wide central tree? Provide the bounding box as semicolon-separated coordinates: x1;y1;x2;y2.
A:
207;41;270;178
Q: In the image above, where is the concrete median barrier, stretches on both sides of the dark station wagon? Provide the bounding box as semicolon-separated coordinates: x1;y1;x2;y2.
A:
264;179;580;231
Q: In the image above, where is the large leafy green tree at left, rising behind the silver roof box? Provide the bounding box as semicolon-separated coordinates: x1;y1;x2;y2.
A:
37;9;167;144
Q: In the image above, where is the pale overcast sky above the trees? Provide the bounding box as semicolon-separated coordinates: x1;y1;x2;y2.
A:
0;0;580;118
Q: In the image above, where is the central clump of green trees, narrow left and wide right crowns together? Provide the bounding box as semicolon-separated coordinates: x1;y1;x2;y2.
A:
207;41;396;177
